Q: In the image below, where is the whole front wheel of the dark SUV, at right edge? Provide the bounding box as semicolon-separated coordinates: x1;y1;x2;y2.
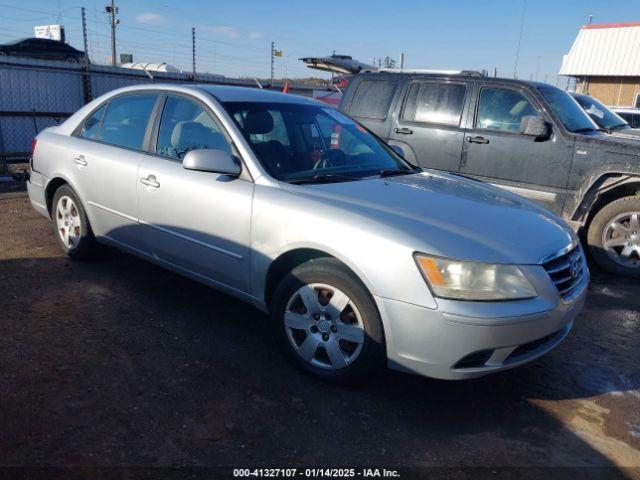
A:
588;196;640;278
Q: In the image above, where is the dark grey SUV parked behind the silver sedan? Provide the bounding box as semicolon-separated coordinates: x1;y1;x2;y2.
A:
340;70;640;278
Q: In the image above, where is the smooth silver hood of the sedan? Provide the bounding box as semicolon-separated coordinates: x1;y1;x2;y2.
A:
294;172;575;264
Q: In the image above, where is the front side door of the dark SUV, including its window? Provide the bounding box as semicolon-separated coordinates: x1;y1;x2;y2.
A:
460;84;572;213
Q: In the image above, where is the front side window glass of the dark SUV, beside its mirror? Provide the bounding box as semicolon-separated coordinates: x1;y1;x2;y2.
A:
476;88;538;132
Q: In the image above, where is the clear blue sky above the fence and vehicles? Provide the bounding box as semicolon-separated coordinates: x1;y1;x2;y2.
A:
0;0;640;83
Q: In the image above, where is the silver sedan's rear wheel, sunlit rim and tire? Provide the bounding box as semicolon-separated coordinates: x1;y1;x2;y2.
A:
51;185;95;259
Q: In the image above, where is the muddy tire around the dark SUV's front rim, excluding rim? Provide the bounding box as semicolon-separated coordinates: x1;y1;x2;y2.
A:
587;196;640;278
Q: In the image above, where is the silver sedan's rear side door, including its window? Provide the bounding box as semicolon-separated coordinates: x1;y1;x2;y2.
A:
67;92;158;248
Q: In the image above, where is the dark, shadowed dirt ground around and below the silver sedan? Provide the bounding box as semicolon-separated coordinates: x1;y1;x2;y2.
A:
0;186;640;478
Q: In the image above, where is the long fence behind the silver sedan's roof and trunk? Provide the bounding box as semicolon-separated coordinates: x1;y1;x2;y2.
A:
0;56;318;179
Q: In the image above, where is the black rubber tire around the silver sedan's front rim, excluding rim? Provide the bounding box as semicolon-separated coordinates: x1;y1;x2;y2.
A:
270;258;386;382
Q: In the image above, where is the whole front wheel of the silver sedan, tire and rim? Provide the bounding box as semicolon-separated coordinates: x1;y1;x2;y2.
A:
271;258;385;381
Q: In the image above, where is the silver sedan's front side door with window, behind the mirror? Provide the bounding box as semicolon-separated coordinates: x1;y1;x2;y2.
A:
137;94;254;292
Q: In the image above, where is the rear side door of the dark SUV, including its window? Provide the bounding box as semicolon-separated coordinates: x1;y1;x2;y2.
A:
389;80;470;172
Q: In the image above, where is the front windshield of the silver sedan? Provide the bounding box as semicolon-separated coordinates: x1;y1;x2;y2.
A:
224;102;417;183
